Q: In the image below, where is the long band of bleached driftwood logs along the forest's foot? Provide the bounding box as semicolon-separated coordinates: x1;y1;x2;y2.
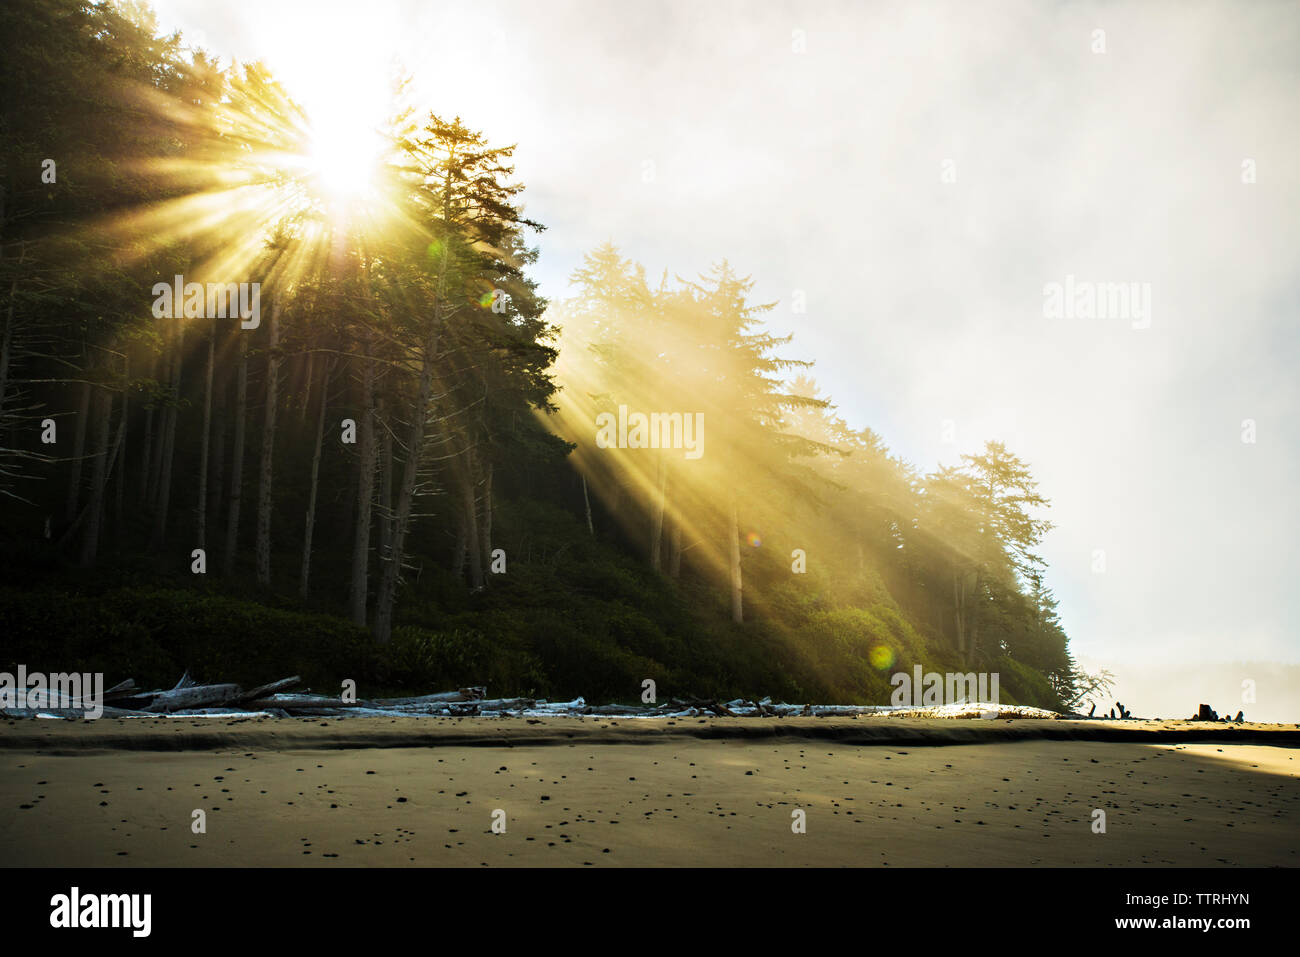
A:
4;674;1058;718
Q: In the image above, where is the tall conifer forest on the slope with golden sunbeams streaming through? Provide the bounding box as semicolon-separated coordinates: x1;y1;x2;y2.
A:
0;0;1089;710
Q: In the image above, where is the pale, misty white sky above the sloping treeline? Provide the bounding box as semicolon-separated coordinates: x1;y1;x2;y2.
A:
147;0;1300;720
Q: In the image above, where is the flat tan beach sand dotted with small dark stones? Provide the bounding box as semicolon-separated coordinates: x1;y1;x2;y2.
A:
0;718;1300;867
